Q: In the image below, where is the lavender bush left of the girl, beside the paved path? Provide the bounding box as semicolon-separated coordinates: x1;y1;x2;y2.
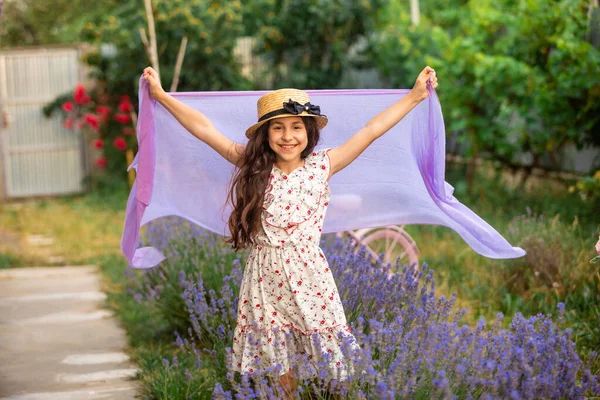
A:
129;217;245;340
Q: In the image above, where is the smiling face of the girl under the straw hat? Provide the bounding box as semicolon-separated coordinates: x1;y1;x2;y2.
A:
269;117;308;162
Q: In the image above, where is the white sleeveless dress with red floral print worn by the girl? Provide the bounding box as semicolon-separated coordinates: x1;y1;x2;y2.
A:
231;149;355;379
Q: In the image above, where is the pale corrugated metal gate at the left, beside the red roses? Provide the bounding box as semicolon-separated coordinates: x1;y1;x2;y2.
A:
0;48;87;200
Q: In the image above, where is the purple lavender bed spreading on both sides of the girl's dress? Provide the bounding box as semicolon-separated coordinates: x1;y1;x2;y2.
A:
130;217;600;399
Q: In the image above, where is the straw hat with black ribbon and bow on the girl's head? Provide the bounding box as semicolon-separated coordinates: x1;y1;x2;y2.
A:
246;89;327;138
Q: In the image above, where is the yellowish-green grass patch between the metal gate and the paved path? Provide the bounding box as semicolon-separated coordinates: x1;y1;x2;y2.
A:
0;191;127;266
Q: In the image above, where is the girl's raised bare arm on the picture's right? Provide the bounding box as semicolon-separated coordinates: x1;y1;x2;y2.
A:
327;67;437;179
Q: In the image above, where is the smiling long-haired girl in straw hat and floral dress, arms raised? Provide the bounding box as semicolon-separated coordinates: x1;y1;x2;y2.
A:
143;67;438;398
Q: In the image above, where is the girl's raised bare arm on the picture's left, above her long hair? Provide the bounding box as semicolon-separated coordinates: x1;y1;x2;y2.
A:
144;67;245;165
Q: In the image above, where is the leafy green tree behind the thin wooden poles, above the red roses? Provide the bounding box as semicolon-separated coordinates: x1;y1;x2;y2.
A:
82;0;249;93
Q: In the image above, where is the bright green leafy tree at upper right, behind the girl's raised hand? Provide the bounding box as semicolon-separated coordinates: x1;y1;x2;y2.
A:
374;0;600;184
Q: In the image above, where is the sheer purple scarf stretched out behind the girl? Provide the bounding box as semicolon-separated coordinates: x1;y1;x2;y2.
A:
121;78;525;268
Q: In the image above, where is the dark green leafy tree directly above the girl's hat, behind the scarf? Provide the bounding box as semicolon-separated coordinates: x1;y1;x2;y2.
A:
244;0;384;88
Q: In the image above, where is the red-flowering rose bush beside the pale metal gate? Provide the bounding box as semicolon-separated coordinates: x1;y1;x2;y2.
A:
44;84;137;188
